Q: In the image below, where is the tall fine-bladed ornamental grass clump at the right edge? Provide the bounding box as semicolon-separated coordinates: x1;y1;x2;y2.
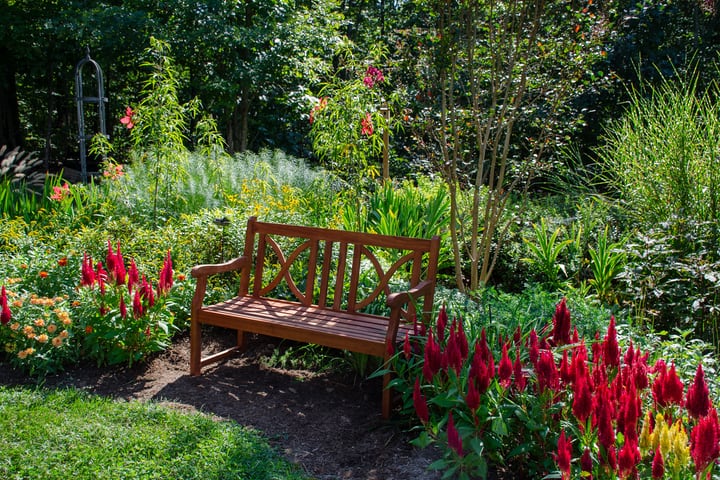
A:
598;69;720;225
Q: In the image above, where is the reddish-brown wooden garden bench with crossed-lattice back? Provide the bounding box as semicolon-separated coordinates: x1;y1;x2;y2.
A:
190;217;440;418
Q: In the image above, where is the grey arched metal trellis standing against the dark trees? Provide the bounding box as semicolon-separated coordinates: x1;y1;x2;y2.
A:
75;48;108;183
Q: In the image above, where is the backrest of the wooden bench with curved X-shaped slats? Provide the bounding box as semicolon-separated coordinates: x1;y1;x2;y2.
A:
240;217;440;319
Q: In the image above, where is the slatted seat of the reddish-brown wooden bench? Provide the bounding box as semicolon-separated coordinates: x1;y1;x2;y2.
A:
198;297;411;356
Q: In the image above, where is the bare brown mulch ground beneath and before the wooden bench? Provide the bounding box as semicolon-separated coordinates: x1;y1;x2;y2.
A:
0;329;440;480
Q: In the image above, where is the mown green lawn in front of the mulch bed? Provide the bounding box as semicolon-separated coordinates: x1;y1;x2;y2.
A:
0;387;307;480
